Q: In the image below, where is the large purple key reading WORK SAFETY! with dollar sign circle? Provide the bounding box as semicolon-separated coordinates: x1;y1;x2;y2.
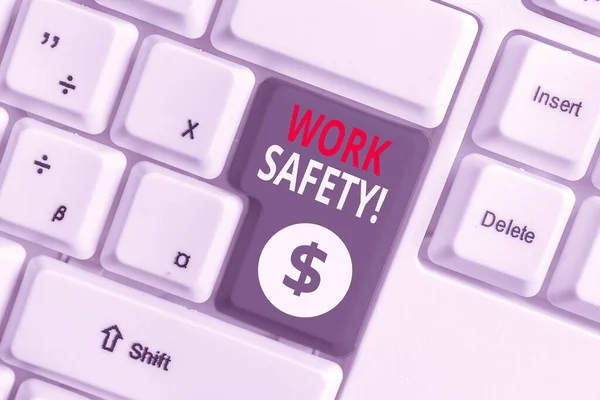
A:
217;80;429;356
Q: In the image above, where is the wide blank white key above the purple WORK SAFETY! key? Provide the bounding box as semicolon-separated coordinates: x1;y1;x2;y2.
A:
211;0;478;128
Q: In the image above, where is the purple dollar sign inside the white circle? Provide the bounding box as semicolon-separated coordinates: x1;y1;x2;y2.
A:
283;242;327;296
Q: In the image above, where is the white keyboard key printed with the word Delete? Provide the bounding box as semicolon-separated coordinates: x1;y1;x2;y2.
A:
429;155;575;297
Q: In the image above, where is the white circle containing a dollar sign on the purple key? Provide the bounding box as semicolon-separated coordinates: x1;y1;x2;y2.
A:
258;224;352;318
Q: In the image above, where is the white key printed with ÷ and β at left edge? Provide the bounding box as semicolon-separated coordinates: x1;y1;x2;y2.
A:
0;119;126;259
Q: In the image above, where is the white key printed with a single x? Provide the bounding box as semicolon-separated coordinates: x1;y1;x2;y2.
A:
111;36;254;179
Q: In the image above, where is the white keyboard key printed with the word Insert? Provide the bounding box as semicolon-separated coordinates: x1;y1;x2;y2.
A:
473;36;600;180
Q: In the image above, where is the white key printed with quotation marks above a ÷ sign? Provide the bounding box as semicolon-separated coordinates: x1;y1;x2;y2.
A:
0;0;137;134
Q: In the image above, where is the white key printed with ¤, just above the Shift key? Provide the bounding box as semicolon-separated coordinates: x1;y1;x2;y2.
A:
102;162;243;302
